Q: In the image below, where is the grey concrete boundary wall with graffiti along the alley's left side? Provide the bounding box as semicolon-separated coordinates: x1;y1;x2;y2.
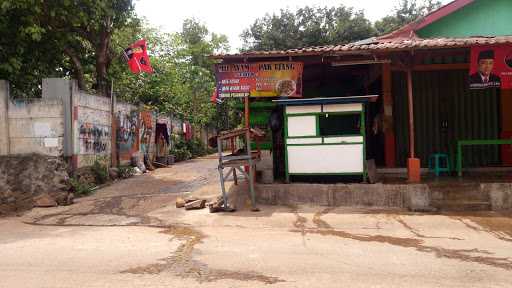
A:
0;78;165;169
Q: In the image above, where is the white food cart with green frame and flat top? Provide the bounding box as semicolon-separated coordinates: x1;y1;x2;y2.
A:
274;95;378;182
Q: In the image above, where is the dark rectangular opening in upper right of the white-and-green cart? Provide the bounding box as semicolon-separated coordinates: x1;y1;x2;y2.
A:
318;114;361;136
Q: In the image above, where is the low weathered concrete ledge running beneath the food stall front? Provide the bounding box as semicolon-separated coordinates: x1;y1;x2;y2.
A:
230;183;512;211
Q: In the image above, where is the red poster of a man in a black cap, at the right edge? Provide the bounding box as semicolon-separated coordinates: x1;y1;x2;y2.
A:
469;45;512;89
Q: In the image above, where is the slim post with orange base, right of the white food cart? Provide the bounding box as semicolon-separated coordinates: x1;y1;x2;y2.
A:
407;65;421;182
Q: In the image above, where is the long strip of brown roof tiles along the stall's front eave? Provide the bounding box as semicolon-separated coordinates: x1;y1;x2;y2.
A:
212;36;512;59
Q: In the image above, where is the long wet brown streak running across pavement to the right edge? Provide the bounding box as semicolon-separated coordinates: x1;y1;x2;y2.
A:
290;212;512;271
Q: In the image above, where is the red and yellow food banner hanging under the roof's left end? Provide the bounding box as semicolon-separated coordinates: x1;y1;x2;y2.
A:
215;62;304;99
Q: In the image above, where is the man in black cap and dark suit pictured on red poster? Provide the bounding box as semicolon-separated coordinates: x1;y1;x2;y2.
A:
469;50;501;89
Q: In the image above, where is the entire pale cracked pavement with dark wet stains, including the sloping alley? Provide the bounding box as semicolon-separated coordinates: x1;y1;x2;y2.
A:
0;157;512;288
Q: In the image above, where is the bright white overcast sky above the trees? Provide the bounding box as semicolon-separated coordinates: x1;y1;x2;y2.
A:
136;0;450;51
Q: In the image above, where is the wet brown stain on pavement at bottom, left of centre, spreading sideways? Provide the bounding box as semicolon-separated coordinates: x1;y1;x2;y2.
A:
121;226;285;284
